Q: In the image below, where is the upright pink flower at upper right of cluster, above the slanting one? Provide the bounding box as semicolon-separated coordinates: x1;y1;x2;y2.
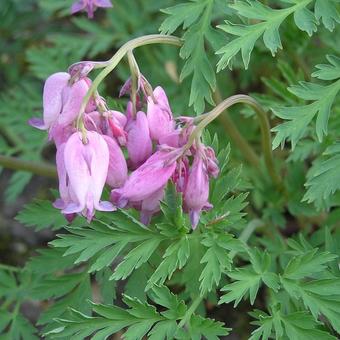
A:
147;86;175;142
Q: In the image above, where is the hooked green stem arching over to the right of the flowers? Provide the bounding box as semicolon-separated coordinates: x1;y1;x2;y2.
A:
185;94;282;190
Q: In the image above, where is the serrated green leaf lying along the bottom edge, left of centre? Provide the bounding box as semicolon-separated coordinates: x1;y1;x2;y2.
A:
47;286;228;340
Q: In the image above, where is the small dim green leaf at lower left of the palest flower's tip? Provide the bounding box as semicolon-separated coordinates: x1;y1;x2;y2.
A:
16;200;67;230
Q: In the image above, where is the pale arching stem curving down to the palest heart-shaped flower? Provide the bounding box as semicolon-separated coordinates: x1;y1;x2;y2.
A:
77;34;182;129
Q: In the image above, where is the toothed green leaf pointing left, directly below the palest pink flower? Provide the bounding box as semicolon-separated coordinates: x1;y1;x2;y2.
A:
50;211;164;272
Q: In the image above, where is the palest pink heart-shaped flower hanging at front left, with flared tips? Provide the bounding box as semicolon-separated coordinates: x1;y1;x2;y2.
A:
62;131;114;221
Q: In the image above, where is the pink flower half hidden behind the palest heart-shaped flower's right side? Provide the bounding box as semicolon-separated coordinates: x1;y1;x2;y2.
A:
103;136;128;188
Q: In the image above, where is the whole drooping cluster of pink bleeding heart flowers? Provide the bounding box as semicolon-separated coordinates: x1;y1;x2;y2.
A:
30;63;219;228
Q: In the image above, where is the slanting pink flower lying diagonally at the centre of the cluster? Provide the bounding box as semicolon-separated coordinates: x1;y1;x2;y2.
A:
111;149;182;208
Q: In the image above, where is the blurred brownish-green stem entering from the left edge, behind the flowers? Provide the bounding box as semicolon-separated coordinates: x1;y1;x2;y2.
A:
0;155;57;178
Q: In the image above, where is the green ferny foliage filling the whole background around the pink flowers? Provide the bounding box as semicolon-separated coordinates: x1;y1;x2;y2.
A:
0;0;340;340
